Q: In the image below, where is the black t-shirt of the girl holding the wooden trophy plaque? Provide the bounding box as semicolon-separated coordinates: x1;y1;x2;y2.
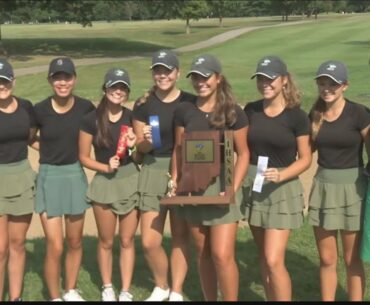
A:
174;101;248;132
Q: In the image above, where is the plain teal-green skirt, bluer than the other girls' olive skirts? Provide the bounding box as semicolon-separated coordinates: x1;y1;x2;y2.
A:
35;162;91;217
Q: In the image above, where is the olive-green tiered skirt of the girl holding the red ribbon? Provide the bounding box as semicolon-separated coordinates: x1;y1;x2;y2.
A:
86;162;139;215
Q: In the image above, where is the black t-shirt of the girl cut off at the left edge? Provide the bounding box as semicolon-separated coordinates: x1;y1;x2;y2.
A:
0;97;36;164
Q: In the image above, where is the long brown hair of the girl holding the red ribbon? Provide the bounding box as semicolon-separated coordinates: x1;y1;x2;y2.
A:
96;86;113;148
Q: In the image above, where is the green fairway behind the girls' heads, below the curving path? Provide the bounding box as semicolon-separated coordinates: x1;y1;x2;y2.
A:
10;14;370;110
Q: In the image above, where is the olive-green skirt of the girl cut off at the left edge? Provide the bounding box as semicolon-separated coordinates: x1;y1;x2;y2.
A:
0;159;36;216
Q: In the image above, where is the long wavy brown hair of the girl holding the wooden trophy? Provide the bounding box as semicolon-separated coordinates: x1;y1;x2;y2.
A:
210;74;236;128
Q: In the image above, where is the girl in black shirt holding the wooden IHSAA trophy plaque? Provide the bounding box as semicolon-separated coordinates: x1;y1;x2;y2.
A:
171;54;249;301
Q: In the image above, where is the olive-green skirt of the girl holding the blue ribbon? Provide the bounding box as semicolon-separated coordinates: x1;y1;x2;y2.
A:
138;154;171;212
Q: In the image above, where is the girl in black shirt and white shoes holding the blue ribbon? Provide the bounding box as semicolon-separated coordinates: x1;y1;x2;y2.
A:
133;50;195;301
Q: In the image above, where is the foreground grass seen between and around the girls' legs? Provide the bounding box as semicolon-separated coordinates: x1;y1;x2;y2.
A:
5;220;370;301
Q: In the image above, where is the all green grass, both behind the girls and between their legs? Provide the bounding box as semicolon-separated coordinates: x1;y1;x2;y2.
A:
2;14;370;301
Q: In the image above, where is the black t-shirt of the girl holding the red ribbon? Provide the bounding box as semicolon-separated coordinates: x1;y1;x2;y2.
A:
80;107;132;165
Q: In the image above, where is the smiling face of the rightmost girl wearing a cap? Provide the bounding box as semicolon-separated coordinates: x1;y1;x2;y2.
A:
316;76;348;103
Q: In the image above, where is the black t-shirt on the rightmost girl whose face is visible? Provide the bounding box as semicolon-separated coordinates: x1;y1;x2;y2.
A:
310;100;370;169
